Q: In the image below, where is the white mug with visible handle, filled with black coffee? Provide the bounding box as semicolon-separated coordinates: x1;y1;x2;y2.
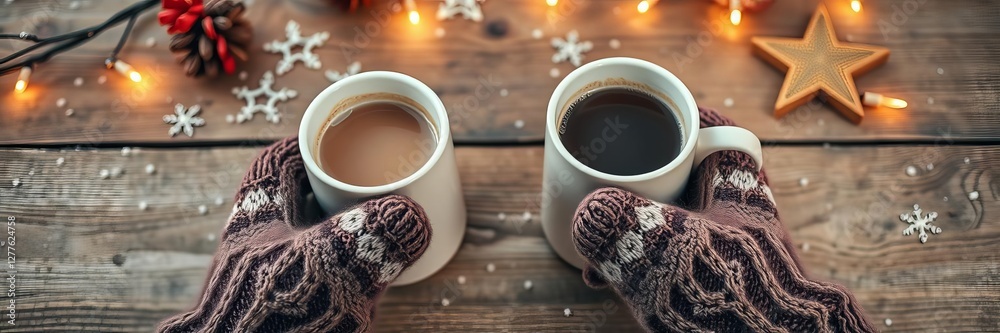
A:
541;58;762;268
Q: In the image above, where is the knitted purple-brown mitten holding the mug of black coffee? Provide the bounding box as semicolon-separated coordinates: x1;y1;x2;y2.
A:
573;110;874;332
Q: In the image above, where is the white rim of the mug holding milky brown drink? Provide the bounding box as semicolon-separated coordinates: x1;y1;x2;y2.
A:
298;71;451;195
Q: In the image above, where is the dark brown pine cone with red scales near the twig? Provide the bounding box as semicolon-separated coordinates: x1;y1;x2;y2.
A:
170;0;253;77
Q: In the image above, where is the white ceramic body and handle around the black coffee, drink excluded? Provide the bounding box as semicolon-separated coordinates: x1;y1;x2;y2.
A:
542;58;762;268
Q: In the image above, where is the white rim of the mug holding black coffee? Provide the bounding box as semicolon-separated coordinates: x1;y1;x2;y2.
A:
545;57;701;183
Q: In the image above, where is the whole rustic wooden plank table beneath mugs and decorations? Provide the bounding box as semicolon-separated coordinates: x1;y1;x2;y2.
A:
0;0;1000;332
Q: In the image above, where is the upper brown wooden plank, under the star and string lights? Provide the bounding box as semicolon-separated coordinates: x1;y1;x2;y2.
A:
0;0;1000;145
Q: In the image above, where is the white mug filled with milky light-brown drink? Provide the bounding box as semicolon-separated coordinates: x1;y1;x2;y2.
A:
299;72;466;286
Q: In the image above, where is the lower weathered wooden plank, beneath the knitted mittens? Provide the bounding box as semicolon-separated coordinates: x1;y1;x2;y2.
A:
0;145;1000;332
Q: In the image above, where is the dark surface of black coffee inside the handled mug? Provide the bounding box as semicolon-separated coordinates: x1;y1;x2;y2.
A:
559;87;684;176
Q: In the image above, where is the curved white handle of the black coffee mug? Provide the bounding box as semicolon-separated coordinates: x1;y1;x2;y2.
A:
694;126;764;171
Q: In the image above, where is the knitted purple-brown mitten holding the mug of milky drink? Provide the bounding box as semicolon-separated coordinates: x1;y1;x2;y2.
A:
159;137;431;332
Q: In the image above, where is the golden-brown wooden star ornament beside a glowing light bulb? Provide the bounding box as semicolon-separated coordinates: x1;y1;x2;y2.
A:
751;5;889;124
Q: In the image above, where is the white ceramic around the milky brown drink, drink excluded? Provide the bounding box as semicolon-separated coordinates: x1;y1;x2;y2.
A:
299;72;466;286
